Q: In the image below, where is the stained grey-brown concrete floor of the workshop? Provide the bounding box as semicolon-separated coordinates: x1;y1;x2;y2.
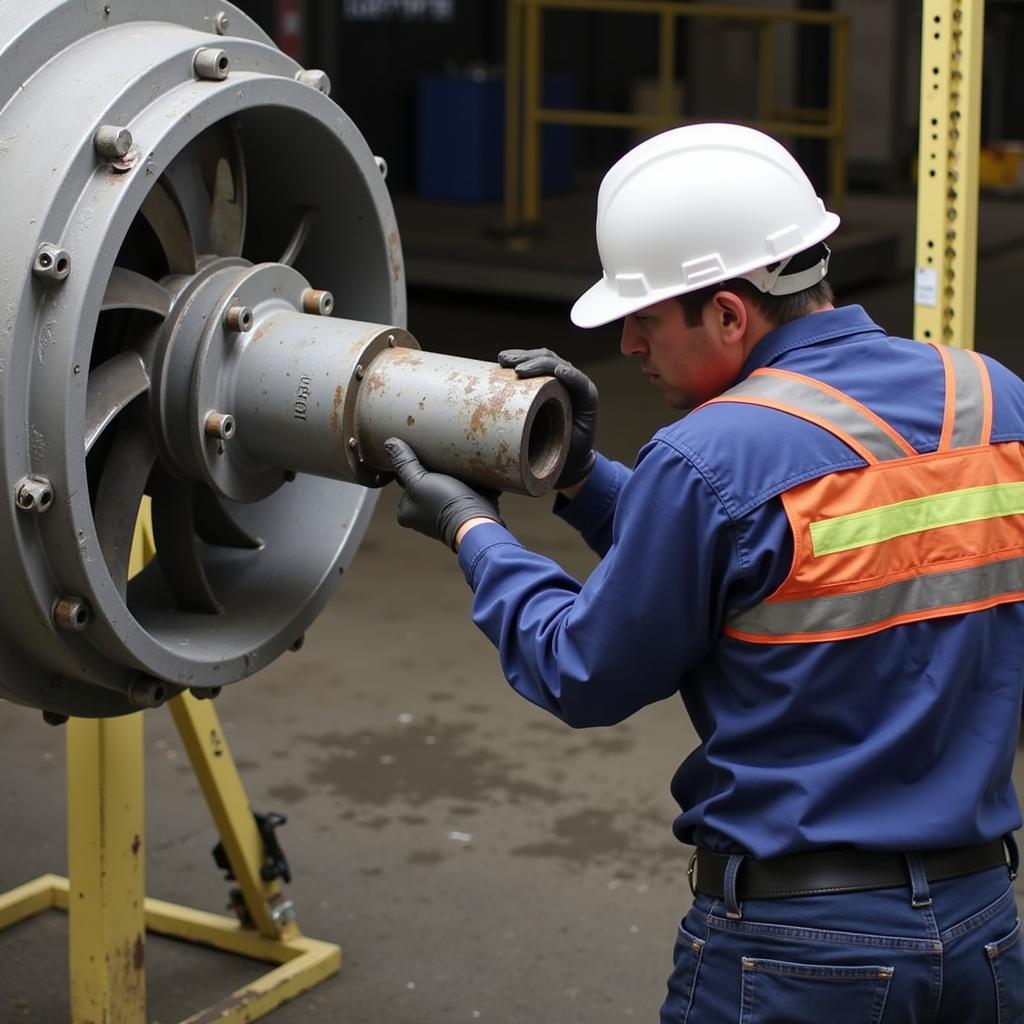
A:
6;195;1024;1024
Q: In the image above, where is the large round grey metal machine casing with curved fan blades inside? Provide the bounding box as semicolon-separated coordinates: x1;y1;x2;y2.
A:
0;0;406;716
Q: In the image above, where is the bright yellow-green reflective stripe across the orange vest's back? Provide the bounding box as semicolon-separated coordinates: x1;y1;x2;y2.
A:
811;483;1024;558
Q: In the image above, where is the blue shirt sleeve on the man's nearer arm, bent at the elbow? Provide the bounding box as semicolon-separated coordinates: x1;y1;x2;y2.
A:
459;439;736;727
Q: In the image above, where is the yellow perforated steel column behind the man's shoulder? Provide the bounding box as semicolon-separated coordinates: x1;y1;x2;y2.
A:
913;0;985;348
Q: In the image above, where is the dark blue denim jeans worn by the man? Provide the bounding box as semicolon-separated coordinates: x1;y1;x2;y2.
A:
662;857;1024;1024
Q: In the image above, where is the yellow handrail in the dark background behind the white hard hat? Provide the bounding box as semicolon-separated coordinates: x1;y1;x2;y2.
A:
505;0;849;234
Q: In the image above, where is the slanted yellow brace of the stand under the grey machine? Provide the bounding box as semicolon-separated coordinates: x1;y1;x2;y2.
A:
167;693;290;938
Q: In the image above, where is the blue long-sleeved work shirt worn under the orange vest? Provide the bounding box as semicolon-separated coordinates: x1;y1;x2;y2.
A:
459;306;1024;858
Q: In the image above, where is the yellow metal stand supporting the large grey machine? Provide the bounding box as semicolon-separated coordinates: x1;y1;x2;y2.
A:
0;507;341;1024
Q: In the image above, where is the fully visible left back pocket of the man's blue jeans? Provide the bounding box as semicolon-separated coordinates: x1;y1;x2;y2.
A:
739;956;893;1024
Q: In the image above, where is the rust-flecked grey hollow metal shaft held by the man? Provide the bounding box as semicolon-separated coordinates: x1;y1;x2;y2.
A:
229;312;570;495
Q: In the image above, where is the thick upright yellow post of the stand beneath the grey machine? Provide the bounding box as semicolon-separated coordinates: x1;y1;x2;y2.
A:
68;714;145;1024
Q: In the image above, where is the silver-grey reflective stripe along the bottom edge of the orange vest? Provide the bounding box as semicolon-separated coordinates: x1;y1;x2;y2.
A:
728;558;1024;639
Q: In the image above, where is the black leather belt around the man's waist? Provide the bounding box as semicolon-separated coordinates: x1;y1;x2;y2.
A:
688;839;1007;899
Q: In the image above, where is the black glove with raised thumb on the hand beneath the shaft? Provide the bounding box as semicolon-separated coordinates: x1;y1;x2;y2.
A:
384;437;502;551
